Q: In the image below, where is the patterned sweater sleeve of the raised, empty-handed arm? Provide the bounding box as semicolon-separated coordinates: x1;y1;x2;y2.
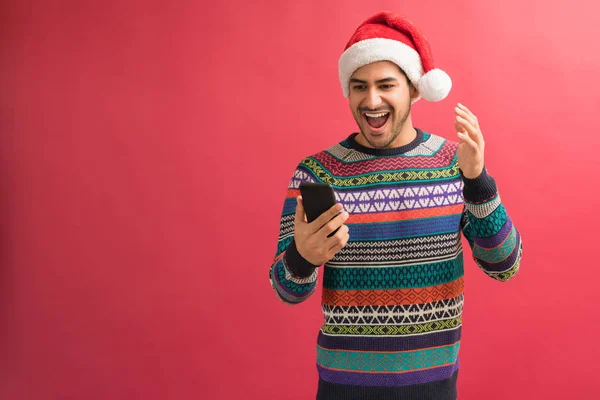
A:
460;166;523;282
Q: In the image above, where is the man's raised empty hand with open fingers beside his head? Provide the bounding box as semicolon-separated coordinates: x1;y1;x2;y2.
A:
454;103;485;179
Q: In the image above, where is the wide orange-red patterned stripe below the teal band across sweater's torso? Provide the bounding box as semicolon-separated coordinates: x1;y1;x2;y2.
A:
322;278;464;306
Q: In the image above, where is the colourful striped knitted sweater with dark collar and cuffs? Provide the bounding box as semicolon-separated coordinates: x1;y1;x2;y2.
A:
269;128;522;400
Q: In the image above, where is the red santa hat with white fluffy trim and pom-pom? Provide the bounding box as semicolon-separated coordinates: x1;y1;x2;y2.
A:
338;12;452;103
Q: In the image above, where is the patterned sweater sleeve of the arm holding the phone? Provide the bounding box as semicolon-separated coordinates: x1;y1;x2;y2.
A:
269;161;319;305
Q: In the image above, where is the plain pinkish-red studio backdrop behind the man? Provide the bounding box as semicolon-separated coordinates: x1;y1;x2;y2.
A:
0;0;600;400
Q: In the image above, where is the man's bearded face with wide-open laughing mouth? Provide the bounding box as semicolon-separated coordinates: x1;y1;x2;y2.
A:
348;61;415;148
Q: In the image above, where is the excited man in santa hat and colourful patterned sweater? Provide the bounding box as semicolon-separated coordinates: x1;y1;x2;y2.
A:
269;13;522;400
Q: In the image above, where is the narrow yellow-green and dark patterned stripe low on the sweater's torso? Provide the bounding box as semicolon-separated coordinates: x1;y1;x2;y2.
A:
321;316;462;336
